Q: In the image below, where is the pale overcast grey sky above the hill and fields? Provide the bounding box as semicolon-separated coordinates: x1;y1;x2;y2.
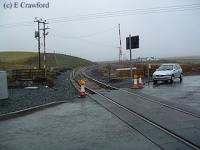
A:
0;0;200;61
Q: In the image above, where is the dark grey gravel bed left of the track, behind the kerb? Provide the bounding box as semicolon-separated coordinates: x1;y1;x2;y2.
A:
0;71;77;114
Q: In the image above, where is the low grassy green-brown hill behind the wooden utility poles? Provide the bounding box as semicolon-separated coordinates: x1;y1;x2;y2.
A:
0;52;92;70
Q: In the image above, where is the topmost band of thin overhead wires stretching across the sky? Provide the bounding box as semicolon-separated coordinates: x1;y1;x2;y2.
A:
0;4;200;28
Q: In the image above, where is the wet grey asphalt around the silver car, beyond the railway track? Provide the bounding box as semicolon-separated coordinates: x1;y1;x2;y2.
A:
136;76;200;114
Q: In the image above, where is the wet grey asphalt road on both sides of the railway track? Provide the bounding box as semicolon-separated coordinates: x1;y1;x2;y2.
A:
0;71;200;150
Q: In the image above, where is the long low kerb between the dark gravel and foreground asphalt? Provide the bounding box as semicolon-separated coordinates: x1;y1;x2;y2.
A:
0;101;67;121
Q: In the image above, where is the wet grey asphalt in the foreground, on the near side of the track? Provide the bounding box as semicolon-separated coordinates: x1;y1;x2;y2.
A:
0;98;159;150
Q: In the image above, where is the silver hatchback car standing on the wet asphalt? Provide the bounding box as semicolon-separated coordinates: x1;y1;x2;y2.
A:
153;64;183;84
